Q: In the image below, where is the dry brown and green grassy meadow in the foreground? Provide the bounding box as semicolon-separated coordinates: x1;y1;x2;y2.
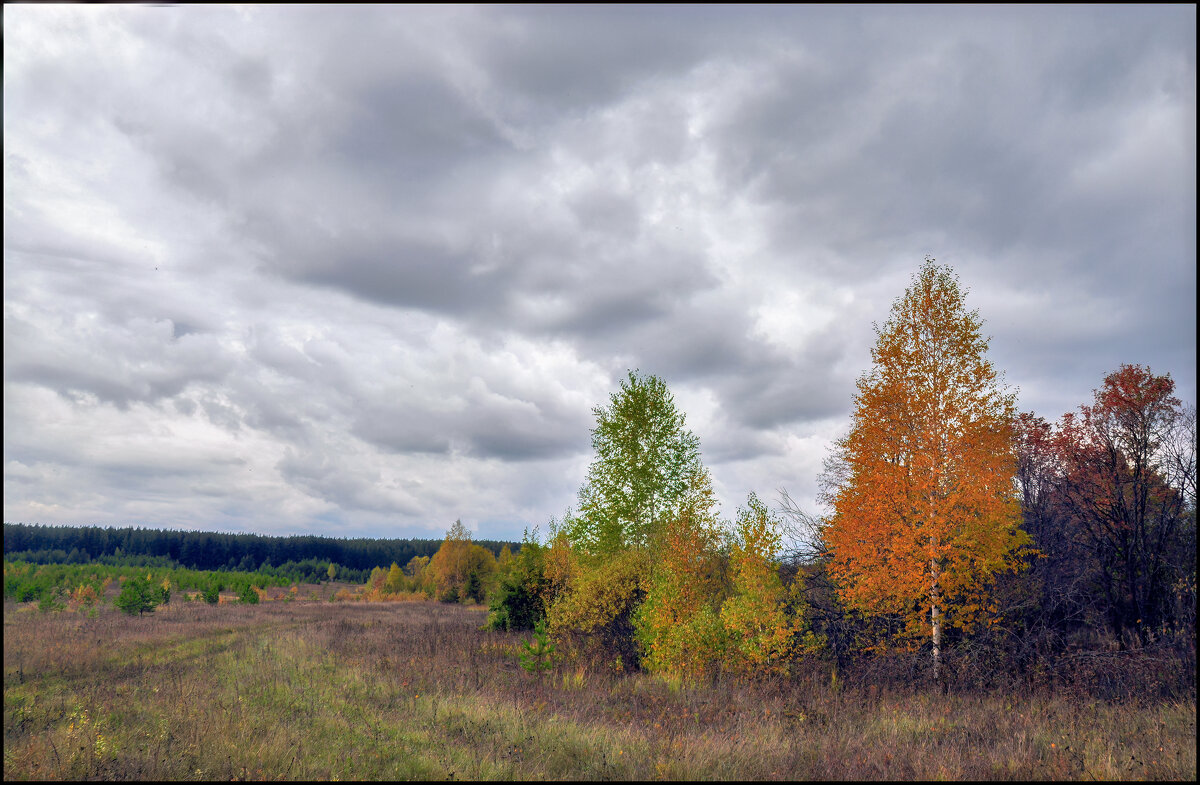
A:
4;600;1196;780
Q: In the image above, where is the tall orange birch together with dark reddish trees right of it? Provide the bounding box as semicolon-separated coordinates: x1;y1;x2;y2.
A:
811;259;1195;676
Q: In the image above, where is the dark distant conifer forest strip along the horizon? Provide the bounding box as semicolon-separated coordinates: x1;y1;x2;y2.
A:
4;523;520;581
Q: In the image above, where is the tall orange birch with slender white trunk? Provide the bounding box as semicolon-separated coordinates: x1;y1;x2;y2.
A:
826;257;1028;678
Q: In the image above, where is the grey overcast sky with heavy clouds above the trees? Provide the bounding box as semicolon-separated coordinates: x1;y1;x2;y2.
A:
4;5;1196;547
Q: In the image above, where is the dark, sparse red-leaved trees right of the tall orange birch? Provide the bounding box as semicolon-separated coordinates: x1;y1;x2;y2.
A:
1014;365;1196;648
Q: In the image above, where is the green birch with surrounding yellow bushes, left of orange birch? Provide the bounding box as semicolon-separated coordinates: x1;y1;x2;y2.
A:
492;371;817;681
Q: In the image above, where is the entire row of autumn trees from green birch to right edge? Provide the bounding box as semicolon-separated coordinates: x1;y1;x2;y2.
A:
484;259;1196;681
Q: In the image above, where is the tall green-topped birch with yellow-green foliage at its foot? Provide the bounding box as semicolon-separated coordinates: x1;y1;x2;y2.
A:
546;371;715;667
